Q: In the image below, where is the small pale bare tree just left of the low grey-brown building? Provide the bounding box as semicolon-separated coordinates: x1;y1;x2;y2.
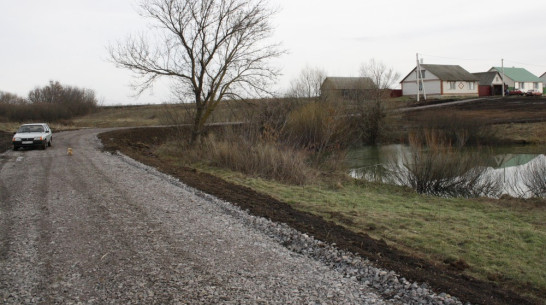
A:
287;66;326;98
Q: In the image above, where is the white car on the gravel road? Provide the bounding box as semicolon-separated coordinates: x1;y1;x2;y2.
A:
12;123;53;150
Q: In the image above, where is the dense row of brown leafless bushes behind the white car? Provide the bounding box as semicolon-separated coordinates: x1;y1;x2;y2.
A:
0;82;98;122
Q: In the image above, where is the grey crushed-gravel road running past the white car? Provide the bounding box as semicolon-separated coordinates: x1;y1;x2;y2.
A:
0;130;460;304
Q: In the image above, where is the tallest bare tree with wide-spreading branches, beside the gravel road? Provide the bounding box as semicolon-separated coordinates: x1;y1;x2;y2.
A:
109;0;284;143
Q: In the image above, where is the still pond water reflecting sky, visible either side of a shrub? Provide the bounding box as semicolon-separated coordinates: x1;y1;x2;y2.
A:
345;144;546;197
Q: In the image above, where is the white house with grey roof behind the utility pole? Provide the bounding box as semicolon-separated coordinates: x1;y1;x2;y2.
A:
400;64;478;96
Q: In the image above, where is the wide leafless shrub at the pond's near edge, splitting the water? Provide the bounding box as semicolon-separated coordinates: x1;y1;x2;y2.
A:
388;134;501;197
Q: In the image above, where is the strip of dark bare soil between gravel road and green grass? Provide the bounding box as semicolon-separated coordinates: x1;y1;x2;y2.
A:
99;128;546;305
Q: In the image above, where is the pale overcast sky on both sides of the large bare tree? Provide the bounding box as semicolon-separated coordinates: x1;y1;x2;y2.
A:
0;0;546;105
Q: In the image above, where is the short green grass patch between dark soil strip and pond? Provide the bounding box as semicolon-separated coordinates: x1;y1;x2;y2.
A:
184;165;546;290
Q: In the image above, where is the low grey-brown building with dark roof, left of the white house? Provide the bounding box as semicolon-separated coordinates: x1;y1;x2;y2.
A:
320;77;375;100
